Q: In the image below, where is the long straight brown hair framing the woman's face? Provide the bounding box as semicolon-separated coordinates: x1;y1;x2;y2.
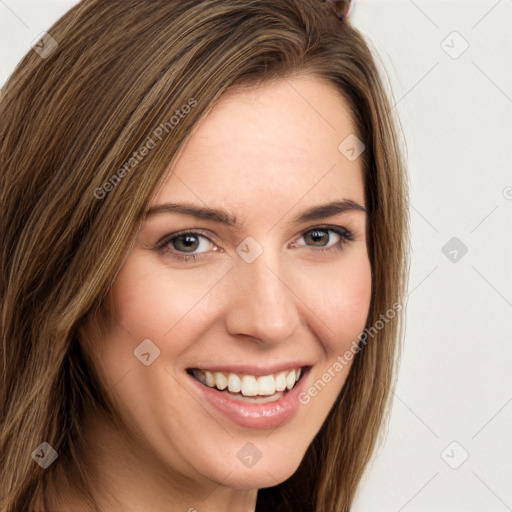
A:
0;0;408;512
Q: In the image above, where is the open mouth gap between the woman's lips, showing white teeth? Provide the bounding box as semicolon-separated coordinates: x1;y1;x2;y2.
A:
187;366;311;403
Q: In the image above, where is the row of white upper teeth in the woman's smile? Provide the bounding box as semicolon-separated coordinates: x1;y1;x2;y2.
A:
193;368;301;396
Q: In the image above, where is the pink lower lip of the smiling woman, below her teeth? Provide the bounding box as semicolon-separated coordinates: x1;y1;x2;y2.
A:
188;368;309;429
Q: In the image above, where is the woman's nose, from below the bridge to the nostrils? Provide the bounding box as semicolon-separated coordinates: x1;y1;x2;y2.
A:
225;246;300;346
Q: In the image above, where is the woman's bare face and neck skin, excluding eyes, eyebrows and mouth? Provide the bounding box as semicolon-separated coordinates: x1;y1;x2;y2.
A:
56;75;371;512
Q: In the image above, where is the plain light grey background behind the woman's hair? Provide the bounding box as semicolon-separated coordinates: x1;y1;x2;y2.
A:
0;0;512;512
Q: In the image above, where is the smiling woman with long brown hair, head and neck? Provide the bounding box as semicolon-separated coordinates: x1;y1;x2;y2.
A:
0;0;407;512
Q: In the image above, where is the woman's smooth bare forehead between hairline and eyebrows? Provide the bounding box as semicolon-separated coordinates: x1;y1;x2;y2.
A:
155;76;364;214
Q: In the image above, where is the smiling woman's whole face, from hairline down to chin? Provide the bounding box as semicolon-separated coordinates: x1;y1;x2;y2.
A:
85;76;371;496
